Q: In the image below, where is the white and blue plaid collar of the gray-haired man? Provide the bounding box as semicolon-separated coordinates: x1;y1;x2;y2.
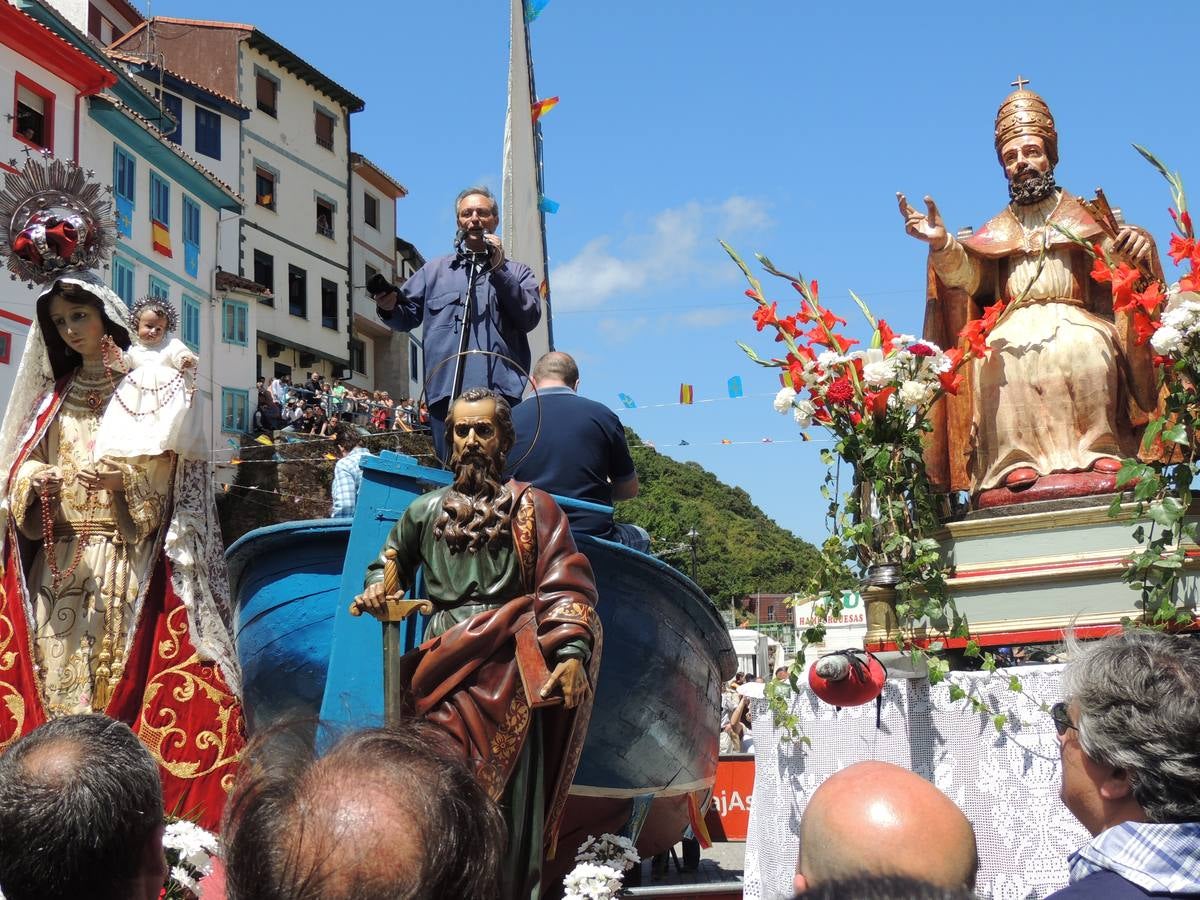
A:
1069;822;1200;894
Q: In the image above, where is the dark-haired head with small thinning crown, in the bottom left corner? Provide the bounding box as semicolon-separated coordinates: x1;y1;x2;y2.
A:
0;714;167;900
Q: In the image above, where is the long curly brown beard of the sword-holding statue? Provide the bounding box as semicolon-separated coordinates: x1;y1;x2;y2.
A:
433;454;512;553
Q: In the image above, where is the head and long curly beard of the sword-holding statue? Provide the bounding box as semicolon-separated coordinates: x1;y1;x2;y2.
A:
433;388;516;553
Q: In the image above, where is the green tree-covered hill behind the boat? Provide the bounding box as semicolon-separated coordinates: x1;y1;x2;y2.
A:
616;428;817;607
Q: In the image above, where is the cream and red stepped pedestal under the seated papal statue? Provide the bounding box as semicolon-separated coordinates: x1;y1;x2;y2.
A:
868;497;1200;649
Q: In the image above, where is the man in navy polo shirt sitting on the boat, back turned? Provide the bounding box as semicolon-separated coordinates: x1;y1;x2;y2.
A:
508;350;650;553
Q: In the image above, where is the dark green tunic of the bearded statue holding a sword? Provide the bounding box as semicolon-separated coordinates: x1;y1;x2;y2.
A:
365;487;592;900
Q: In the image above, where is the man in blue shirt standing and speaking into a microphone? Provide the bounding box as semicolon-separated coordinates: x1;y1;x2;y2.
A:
367;187;541;461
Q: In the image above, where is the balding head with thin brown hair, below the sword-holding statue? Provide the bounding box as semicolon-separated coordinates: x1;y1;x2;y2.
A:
222;721;505;900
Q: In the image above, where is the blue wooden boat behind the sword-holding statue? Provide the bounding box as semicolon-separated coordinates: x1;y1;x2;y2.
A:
227;452;737;858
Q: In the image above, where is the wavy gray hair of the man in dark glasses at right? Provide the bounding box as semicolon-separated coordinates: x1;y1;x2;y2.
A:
1066;630;1200;822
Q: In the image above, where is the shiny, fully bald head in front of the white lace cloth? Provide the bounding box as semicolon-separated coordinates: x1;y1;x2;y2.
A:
796;762;979;890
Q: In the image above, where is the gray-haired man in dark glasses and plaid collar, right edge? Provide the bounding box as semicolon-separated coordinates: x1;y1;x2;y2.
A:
1050;631;1200;900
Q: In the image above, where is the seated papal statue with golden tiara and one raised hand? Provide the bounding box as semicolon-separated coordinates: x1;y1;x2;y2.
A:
898;79;1162;508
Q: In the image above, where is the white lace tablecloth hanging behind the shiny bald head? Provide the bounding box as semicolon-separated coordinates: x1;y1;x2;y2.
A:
745;665;1088;900
